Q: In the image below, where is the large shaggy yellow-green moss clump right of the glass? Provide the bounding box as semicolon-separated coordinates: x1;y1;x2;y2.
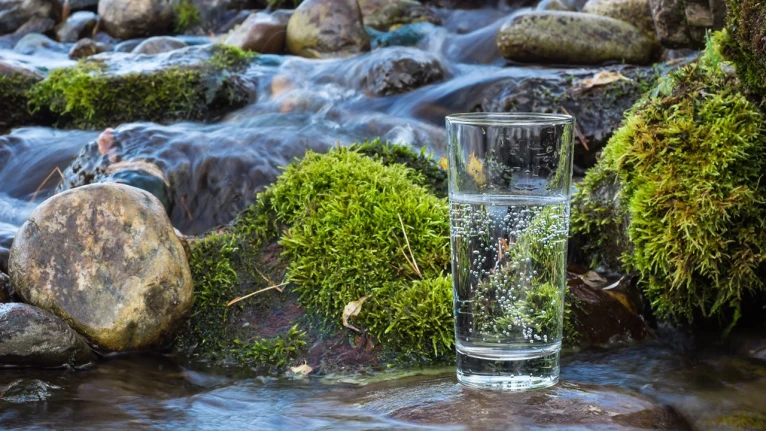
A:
573;33;766;326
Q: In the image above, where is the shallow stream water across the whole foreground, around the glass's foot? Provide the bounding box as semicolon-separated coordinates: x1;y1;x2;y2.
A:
0;340;766;430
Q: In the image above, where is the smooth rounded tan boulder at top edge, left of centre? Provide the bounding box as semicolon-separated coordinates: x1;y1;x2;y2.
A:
286;0;370;58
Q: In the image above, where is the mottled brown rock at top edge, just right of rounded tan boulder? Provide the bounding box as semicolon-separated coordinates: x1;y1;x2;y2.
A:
359;0;441;31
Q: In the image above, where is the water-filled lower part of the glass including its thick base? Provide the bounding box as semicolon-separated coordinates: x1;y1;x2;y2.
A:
450;194;569;389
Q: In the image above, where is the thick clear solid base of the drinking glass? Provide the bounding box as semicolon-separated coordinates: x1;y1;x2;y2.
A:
457;351;559;391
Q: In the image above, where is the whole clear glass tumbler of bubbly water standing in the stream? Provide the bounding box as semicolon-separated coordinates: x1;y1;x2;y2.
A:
447;113;575;390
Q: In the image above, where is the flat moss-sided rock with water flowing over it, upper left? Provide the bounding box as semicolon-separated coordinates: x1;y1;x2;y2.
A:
28;45;254;128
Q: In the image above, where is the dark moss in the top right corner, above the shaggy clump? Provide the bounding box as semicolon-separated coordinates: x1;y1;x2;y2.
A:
718;0;766;99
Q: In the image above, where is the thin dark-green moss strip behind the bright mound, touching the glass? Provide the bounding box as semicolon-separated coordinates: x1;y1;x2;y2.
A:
351;138;447;198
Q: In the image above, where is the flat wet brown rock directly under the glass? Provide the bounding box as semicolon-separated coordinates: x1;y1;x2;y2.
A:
352;376;689;430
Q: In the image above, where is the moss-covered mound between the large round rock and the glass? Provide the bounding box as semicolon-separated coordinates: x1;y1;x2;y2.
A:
177;140;588;372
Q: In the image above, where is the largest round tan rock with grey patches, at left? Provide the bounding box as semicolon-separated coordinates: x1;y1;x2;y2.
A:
8;184;192;352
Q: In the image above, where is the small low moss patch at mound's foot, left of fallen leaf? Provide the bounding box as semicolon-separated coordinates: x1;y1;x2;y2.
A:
235;325;306;374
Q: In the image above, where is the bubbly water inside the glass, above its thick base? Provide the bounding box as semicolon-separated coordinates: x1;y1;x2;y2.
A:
450;198;569;345
